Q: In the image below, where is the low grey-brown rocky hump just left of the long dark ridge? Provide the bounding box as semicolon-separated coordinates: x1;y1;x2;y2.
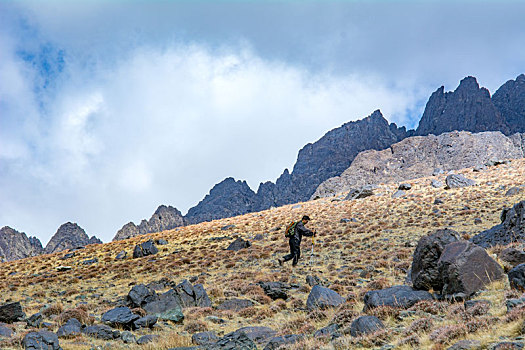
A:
113;205;186;241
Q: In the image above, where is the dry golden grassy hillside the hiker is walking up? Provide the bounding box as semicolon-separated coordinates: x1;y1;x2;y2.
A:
0;160;525;349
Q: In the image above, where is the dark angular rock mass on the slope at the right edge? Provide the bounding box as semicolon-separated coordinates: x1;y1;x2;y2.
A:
471;201;525;248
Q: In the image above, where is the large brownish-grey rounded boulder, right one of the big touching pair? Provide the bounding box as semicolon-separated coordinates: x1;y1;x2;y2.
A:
438;241;503;297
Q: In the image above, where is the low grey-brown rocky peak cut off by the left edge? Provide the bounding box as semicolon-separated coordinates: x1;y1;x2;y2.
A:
0;226;43;261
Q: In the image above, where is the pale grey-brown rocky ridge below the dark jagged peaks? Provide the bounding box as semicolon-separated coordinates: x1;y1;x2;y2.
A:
312;131;524;198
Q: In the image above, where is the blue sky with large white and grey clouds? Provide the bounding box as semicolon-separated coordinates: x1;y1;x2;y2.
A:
0;0;525;245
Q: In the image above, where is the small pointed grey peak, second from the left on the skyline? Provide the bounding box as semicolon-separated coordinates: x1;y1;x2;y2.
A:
44;222;102;254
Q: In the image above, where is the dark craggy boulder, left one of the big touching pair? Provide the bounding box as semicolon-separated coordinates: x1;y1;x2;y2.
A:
411;229;460;290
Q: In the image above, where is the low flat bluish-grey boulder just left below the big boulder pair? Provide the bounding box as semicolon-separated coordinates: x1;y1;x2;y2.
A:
364;286;433;311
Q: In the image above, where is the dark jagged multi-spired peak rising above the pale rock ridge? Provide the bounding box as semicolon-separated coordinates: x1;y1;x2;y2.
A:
416;76;508;135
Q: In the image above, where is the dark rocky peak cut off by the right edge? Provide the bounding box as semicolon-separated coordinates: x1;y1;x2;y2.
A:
492;74;525;134
